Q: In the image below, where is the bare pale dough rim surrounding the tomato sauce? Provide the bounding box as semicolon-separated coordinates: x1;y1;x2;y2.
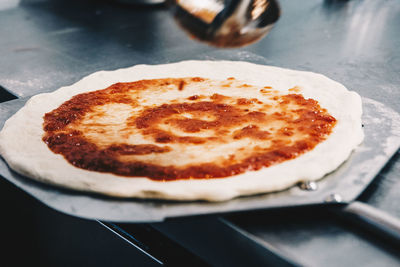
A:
0;61;364;201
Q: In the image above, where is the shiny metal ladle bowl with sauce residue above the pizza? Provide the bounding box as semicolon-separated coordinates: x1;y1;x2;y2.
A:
171;0;280;47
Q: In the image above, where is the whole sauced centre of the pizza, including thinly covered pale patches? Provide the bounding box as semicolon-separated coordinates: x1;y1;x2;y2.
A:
43;77;336;181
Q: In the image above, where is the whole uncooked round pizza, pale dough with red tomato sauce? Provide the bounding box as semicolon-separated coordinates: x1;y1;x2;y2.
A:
0;61;363;201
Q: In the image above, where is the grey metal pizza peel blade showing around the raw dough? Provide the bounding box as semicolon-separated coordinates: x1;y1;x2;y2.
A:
0;98;400;225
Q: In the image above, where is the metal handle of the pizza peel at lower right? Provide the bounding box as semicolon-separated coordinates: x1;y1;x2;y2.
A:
340;201;400;244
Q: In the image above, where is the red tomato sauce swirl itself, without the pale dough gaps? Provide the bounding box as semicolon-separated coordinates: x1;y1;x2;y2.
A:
43;77;336;181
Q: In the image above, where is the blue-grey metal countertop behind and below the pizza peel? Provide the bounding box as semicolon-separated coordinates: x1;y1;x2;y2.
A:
0;0;400;266
